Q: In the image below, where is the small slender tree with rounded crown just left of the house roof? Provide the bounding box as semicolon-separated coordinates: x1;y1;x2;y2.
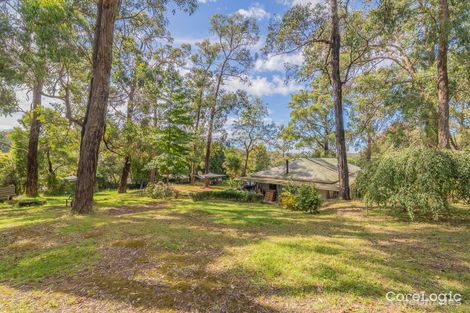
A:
233;98;276;176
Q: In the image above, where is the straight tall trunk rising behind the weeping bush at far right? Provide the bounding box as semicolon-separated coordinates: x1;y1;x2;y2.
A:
437;0;450;149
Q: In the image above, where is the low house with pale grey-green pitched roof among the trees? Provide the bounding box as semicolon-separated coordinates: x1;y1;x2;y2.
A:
241;158;361;201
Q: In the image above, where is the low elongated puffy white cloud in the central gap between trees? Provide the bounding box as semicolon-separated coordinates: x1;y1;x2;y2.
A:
225;75;302;97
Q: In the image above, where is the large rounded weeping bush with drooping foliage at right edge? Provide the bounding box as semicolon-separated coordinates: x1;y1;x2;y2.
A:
357;148;470;220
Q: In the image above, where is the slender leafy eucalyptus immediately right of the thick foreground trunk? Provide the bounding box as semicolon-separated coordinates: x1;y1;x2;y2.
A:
113;6;169;193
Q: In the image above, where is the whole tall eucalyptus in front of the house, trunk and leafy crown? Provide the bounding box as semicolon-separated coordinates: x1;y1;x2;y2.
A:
265;0;375;199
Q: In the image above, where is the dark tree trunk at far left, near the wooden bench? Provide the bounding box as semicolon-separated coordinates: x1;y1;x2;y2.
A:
26;82;42;197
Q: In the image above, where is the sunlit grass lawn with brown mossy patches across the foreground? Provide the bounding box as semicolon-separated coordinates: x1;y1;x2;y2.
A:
0;190;470;313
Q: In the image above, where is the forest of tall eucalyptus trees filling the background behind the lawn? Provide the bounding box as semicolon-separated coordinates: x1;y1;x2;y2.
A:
0;0;470;212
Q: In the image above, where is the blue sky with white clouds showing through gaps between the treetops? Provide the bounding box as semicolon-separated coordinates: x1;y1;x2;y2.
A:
0;0;319;130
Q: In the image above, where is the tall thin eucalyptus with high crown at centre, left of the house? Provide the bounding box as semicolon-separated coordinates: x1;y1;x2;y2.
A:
204;14;259;184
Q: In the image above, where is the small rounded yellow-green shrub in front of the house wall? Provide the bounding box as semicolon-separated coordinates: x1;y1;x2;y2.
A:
279;183;322;213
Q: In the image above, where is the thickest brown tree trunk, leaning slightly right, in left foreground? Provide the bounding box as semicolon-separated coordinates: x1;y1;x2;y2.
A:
72;0;119;214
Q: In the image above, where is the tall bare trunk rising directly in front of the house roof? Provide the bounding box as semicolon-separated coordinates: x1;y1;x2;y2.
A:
330;0;351;200
